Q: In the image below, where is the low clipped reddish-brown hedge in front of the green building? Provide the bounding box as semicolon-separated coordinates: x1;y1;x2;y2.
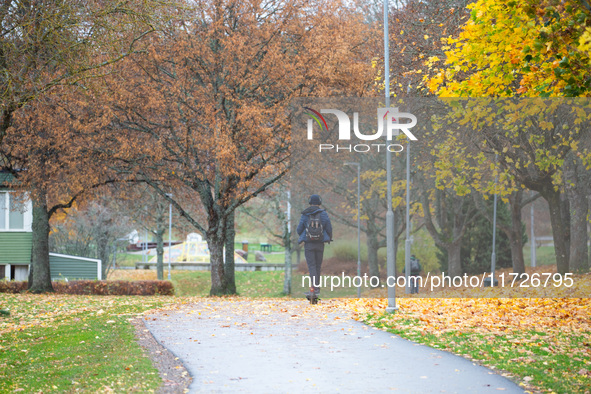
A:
0;280;174;295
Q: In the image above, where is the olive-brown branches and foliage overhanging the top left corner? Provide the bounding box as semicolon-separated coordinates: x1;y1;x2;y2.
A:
0;0;165;148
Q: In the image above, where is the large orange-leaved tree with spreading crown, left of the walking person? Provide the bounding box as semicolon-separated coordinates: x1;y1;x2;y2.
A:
103;0;372;295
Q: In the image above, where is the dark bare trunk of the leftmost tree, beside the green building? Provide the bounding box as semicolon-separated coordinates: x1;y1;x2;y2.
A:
29;191;53;293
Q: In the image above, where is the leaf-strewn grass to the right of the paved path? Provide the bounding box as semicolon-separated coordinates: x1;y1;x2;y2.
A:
347;299;591;393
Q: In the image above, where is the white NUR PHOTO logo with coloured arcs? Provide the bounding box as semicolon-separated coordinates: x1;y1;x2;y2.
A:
304;107;417;152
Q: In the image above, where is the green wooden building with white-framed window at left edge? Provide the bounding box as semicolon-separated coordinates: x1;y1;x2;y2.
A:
0;171;101;281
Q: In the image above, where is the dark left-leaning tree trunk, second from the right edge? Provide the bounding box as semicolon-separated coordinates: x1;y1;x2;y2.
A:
540;187;569;274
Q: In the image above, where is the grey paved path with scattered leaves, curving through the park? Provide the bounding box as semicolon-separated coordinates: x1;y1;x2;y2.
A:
145;300;523;393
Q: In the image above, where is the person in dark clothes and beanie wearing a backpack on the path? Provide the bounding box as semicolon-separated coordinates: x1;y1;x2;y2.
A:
297;194;332;298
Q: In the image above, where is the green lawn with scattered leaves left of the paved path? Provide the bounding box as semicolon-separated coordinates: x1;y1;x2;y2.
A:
0;294;178;393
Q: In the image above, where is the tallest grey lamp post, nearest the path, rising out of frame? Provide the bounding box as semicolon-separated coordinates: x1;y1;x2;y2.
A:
384;0;398;313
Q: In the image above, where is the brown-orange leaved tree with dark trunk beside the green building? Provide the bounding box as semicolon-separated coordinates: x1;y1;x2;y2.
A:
2;95;131;292
